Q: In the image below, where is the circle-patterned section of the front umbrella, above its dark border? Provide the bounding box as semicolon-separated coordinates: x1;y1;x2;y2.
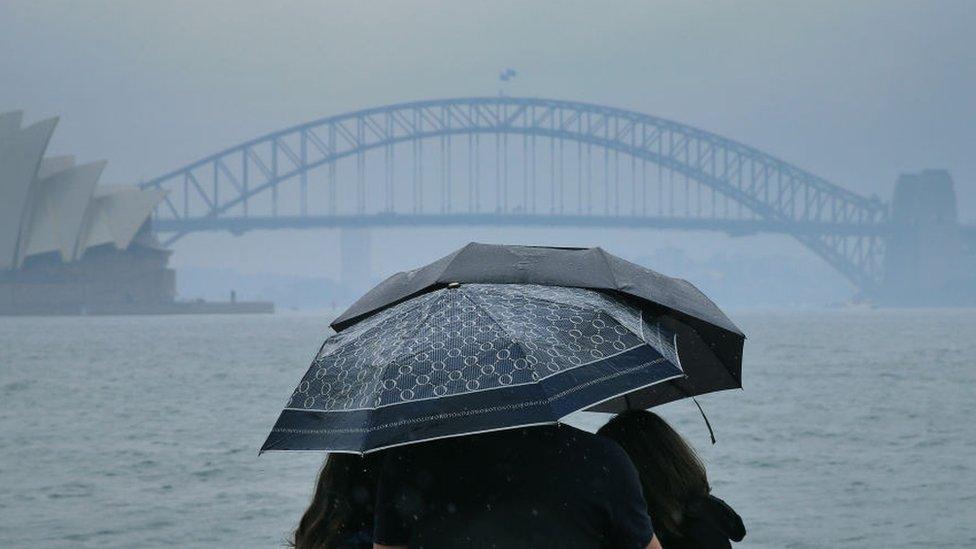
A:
288;284;679;411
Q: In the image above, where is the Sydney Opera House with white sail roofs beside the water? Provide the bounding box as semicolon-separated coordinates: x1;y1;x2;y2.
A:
0;112;175;314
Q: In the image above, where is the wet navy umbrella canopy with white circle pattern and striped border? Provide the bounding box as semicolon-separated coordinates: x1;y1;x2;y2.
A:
262;284;683;452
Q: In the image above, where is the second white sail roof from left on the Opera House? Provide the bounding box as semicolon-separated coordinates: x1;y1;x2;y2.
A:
18;159;106;266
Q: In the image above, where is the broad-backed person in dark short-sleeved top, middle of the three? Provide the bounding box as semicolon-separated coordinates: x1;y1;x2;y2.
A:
373;425;660;549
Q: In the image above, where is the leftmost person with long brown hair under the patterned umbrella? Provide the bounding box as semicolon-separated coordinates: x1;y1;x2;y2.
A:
290;453;383;549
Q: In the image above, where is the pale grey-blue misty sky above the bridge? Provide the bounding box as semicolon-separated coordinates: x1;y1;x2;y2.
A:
0;0;976;286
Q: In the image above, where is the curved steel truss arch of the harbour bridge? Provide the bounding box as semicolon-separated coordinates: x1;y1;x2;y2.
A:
142;97;887;292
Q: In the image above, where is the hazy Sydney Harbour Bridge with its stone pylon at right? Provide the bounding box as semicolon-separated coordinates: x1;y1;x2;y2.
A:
141;97;976;304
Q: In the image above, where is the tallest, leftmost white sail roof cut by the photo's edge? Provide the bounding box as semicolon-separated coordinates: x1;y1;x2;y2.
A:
0;117;58;269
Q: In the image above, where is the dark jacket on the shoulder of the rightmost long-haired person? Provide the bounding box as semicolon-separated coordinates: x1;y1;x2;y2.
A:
657;495;746;549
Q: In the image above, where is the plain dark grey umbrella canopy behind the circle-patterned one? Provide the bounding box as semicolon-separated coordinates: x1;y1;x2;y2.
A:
332;243;745;412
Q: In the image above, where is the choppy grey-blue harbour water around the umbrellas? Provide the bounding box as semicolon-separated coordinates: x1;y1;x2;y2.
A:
0;310;976;549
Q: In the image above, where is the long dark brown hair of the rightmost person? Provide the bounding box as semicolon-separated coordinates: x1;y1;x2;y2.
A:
598;410;711;536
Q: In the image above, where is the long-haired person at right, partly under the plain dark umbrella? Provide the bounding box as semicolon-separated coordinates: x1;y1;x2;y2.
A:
597;410;746;549
